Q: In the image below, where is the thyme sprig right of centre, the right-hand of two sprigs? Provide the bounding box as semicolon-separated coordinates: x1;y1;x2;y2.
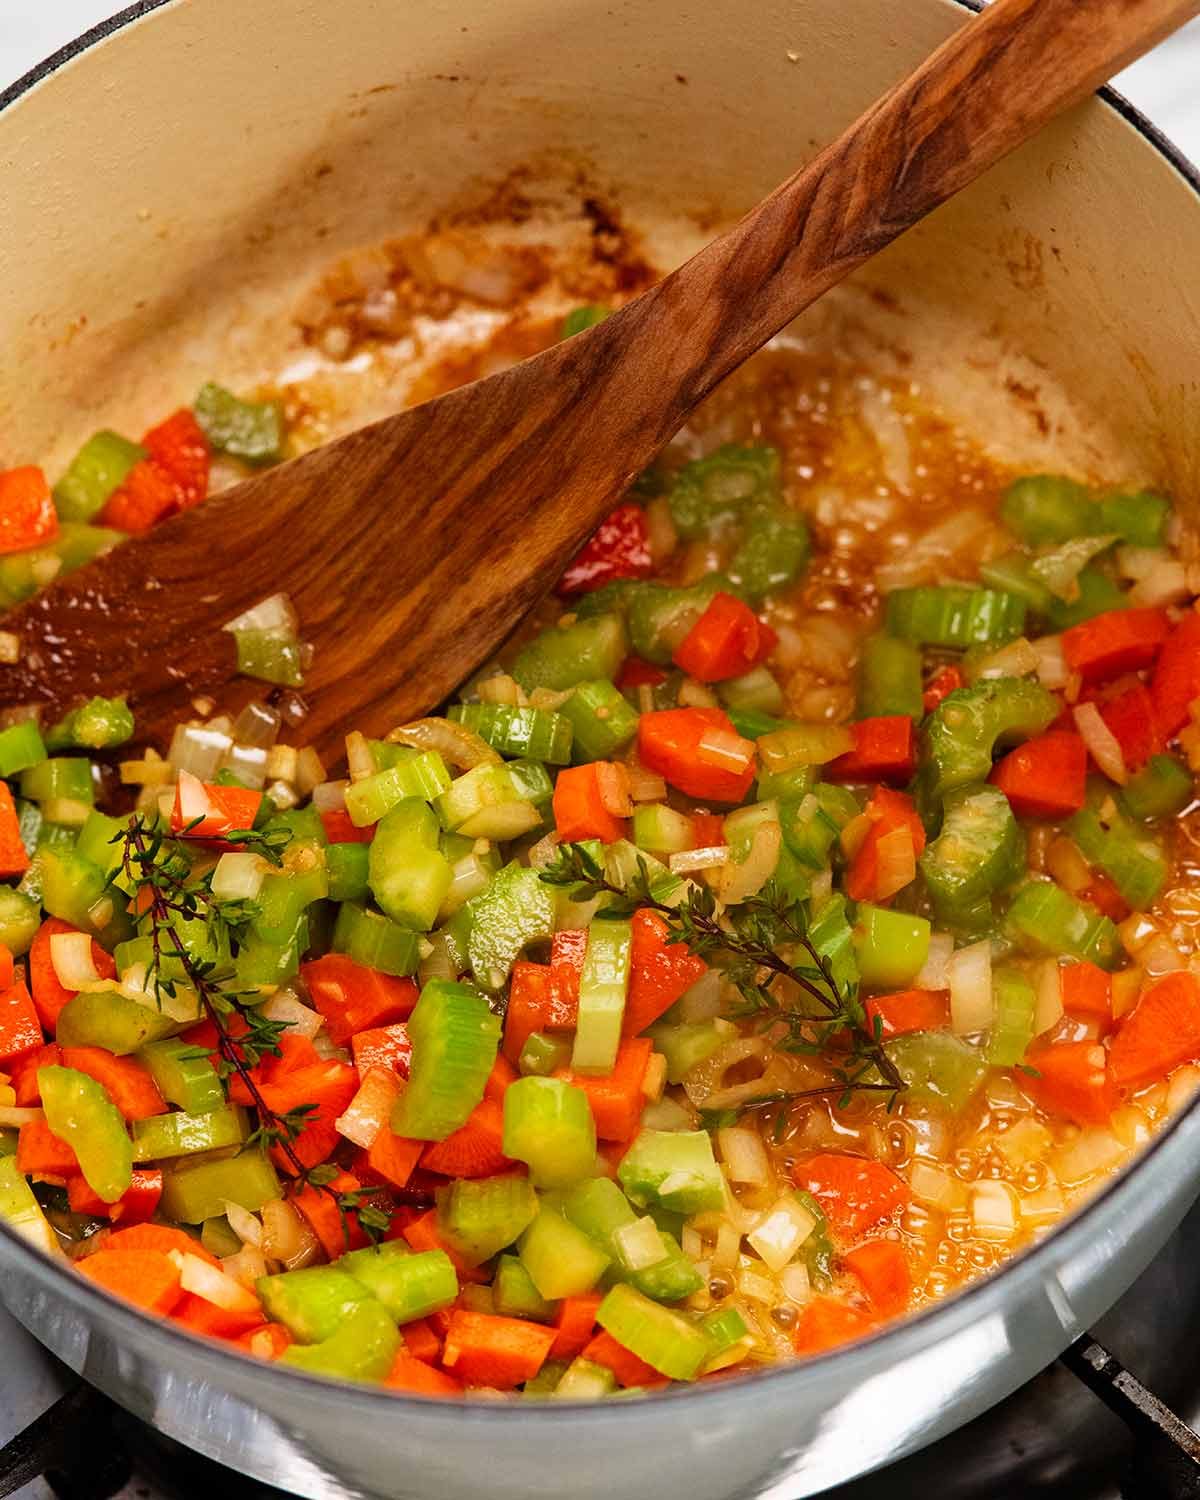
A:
540;843;905;1107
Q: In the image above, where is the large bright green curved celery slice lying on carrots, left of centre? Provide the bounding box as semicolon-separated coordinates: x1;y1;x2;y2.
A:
392;980;500;1140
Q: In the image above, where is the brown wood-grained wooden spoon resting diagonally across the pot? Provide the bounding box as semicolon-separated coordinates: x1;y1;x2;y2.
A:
0;0;1200;750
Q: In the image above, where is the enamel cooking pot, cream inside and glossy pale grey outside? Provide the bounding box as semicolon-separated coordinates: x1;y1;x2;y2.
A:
0;0;1200;1500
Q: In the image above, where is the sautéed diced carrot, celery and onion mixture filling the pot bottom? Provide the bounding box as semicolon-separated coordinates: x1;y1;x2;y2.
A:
0;309;1200;1400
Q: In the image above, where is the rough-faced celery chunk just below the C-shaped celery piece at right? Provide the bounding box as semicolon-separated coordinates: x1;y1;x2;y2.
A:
918;783;1025;926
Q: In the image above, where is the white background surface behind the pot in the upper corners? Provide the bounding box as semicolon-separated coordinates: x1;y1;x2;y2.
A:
0;0;1200;164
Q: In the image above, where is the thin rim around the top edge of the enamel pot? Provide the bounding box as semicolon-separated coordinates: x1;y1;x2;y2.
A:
0;0;1200;1430
